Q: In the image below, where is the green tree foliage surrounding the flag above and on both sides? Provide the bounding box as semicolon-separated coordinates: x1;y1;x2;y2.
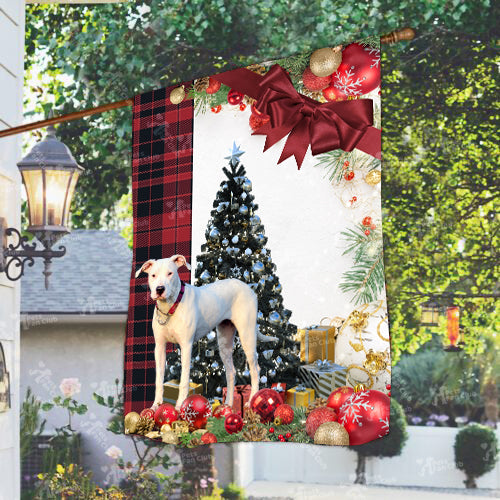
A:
26;0;499;361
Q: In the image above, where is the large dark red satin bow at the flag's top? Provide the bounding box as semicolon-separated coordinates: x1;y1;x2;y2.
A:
253;64;373;169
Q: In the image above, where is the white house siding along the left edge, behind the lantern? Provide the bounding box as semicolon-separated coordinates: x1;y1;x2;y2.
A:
0;0;24;500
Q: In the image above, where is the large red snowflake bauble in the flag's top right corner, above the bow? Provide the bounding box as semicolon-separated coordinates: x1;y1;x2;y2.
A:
332;43;380;97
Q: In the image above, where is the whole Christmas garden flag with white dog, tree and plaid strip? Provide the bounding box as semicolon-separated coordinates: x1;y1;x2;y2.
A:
124;39;391;446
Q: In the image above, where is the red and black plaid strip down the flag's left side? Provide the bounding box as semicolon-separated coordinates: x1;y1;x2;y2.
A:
124;82;193;414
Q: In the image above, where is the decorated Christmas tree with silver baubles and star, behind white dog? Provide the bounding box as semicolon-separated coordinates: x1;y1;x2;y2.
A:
167;144;299;397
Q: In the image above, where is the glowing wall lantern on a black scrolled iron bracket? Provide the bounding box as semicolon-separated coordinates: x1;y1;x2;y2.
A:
0;126;84;289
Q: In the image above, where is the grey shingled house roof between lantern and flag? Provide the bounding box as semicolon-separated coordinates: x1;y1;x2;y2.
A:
21;229;132;315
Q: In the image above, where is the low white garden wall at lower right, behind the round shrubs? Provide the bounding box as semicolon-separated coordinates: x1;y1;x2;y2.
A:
239;426;500;489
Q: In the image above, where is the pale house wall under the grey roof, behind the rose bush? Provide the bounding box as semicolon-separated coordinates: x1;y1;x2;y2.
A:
21;314;143;483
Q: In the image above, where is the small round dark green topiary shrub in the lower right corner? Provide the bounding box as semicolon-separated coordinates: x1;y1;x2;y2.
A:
454;424;498;488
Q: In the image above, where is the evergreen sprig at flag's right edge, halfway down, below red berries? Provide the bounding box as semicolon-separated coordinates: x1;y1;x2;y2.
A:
339;224;385;304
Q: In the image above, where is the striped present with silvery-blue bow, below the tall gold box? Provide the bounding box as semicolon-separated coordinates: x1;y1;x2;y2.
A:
299;359;347;398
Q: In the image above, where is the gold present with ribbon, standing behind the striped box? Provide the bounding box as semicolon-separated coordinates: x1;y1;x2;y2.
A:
297;318;341;363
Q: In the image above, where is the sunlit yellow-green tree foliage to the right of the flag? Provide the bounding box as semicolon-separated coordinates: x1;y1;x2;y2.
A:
382;28;499;361
